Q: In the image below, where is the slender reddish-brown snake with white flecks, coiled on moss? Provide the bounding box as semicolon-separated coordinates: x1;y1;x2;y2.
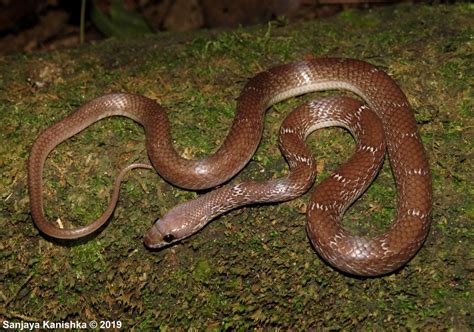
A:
28;58;432;276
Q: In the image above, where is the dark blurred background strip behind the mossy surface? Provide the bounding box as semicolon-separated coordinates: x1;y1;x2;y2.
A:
0;0;450;54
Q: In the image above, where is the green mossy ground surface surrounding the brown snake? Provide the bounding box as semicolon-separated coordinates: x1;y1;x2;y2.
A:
0;4;474;331
